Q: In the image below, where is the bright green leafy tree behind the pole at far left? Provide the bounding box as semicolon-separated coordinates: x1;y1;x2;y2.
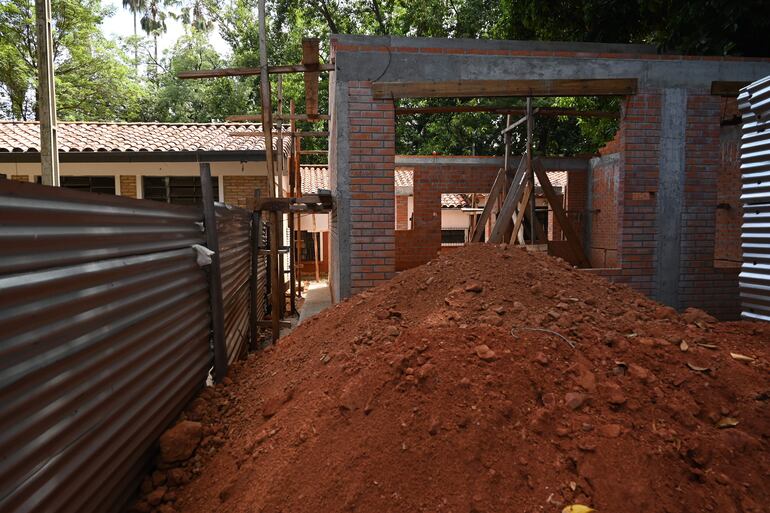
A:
0;0;144;120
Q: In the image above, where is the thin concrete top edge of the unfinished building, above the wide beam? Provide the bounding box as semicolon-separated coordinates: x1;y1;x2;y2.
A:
332;35;657;54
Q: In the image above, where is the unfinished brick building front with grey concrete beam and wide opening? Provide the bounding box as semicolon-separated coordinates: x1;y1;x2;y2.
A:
330;36;770;318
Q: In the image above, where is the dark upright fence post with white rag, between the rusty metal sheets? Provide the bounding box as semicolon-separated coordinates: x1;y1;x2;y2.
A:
200;162;227;383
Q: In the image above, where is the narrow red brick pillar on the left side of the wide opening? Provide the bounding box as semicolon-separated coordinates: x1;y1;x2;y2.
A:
348;81;396;294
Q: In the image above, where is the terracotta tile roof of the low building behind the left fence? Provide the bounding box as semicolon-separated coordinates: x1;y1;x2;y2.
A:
0;121;291;155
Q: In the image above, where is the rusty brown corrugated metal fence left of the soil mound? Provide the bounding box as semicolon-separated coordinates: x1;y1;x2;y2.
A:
0;180;268;512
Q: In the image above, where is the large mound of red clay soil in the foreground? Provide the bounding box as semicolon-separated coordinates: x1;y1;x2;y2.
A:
132;245;770;513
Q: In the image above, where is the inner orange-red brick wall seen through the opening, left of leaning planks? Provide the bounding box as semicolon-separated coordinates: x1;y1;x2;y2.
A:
396;161;499;271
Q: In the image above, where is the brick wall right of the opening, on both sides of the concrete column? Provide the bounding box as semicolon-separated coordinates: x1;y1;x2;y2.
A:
591;92;739;319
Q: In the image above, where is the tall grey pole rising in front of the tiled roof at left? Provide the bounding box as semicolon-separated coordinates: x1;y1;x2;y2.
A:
35;0;60;187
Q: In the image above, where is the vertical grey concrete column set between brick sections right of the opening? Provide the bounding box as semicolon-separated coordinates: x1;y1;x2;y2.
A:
654;89;687;308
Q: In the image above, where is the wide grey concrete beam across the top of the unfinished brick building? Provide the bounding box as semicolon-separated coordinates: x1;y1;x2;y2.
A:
335;36;770;92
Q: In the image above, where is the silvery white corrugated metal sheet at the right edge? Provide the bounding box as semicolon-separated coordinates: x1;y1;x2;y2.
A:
738;77;770;321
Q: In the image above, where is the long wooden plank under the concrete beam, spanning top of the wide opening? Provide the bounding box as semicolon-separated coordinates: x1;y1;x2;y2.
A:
372;78;638;99
